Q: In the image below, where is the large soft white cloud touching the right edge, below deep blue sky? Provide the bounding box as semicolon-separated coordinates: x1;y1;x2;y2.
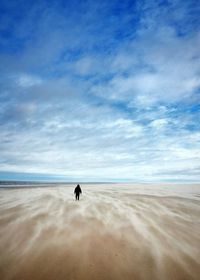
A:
92;25;200;107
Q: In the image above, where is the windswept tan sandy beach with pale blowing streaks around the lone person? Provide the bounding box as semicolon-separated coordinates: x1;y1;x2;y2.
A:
0;184;200;280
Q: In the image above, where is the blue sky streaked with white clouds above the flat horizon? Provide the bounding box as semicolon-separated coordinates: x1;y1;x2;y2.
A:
0;0;200;182
